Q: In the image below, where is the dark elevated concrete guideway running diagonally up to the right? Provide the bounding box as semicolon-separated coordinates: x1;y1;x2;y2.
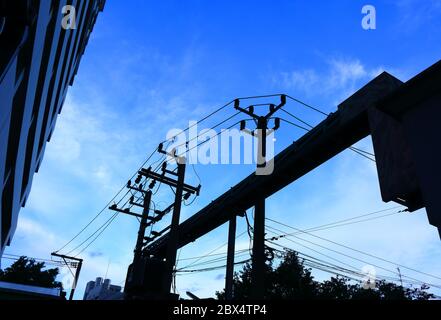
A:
144;62;441;258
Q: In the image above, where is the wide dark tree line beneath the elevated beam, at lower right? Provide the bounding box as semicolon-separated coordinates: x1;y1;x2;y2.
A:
216;251;434;300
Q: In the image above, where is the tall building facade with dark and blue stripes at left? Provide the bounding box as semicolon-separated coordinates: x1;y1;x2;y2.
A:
0;0;105;256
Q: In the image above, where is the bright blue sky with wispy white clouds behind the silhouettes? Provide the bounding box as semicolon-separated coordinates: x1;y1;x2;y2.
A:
3;0;441;298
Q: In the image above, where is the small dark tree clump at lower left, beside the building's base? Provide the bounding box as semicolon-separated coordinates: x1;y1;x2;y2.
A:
0;257;63;289
